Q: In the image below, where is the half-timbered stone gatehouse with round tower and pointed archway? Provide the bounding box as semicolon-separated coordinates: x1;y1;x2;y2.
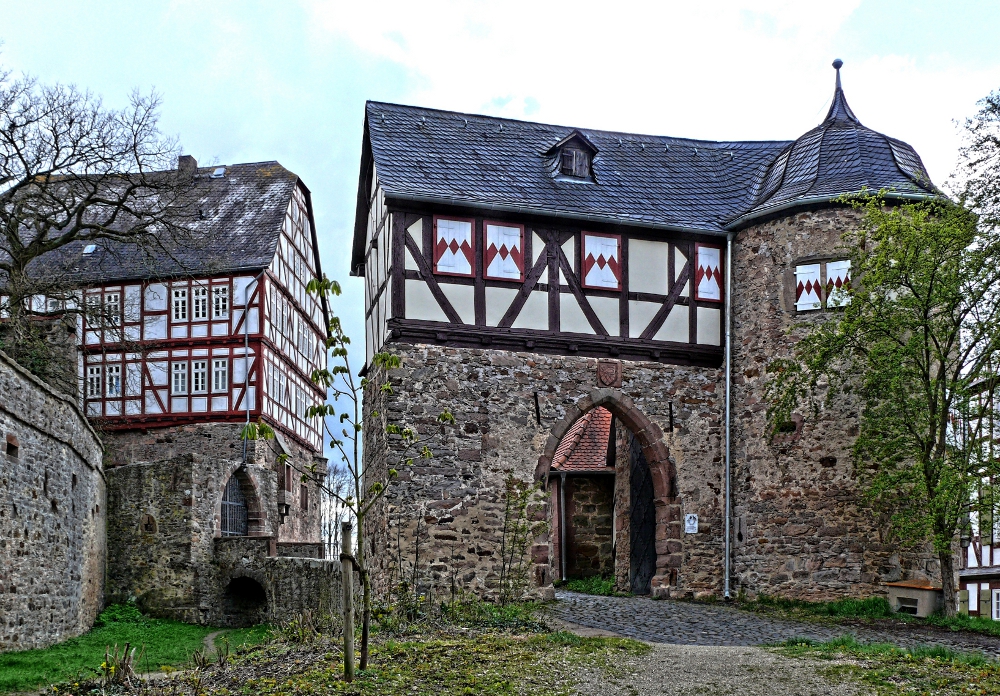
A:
352;62;939;598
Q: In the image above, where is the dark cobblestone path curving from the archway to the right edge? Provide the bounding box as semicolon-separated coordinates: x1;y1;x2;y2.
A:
546;591;1000;656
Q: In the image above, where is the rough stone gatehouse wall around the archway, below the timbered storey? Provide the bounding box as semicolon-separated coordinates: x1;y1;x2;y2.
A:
365;344;722;595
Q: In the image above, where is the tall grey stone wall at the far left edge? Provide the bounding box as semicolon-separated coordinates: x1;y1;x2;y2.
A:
0;353;107;651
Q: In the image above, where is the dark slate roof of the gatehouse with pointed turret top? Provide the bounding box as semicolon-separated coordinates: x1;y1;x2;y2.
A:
351;61;937;272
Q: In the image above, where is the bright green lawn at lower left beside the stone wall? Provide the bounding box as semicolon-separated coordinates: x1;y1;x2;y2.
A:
0;605;266;692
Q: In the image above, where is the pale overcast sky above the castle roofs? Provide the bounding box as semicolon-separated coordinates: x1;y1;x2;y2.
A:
0;0;1000;356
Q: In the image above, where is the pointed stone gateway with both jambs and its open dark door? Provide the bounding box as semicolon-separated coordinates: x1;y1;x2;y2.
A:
535;389;681;596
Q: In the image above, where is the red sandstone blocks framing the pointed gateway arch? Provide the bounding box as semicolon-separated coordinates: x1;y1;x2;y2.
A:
535;389;682;597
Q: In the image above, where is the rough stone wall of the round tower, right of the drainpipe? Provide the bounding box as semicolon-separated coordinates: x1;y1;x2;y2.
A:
732;208;940;600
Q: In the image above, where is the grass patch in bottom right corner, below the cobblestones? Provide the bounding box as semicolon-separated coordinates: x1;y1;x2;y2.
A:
777;636;1000;696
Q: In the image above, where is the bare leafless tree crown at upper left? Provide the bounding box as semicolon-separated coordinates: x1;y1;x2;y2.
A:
0;69;194;370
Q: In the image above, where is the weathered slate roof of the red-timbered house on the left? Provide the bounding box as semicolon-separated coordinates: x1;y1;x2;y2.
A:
29;162;304;286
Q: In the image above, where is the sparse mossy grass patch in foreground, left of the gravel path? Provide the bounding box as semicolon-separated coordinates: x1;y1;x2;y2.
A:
242;633;649;696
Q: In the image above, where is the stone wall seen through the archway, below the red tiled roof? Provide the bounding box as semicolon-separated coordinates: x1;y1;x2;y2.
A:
566;475;615;578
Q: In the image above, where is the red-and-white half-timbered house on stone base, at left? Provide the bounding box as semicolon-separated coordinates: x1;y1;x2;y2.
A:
20;156;328;622
